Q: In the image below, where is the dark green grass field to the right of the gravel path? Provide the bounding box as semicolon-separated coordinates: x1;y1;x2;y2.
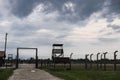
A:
45;65;120;80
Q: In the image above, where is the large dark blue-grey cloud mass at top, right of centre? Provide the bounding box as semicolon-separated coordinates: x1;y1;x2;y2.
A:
43;0;104;23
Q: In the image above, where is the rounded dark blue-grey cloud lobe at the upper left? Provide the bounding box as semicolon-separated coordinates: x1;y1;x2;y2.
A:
9;0;42;17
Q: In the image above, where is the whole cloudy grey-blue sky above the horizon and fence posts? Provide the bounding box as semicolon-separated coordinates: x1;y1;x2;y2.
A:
0;0;120;59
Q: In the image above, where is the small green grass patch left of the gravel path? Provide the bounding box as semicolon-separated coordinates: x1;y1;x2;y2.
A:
0;69;14;80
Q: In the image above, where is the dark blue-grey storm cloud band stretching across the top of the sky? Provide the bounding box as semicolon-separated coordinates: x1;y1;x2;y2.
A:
7;0;120;22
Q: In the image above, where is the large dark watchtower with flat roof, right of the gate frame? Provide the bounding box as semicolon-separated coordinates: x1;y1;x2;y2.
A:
52;44;73;69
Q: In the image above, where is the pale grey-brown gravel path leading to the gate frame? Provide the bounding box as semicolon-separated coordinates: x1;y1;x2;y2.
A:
8;64;63;80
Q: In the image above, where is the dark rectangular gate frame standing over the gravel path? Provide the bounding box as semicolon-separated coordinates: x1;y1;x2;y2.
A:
16;47;38;68
